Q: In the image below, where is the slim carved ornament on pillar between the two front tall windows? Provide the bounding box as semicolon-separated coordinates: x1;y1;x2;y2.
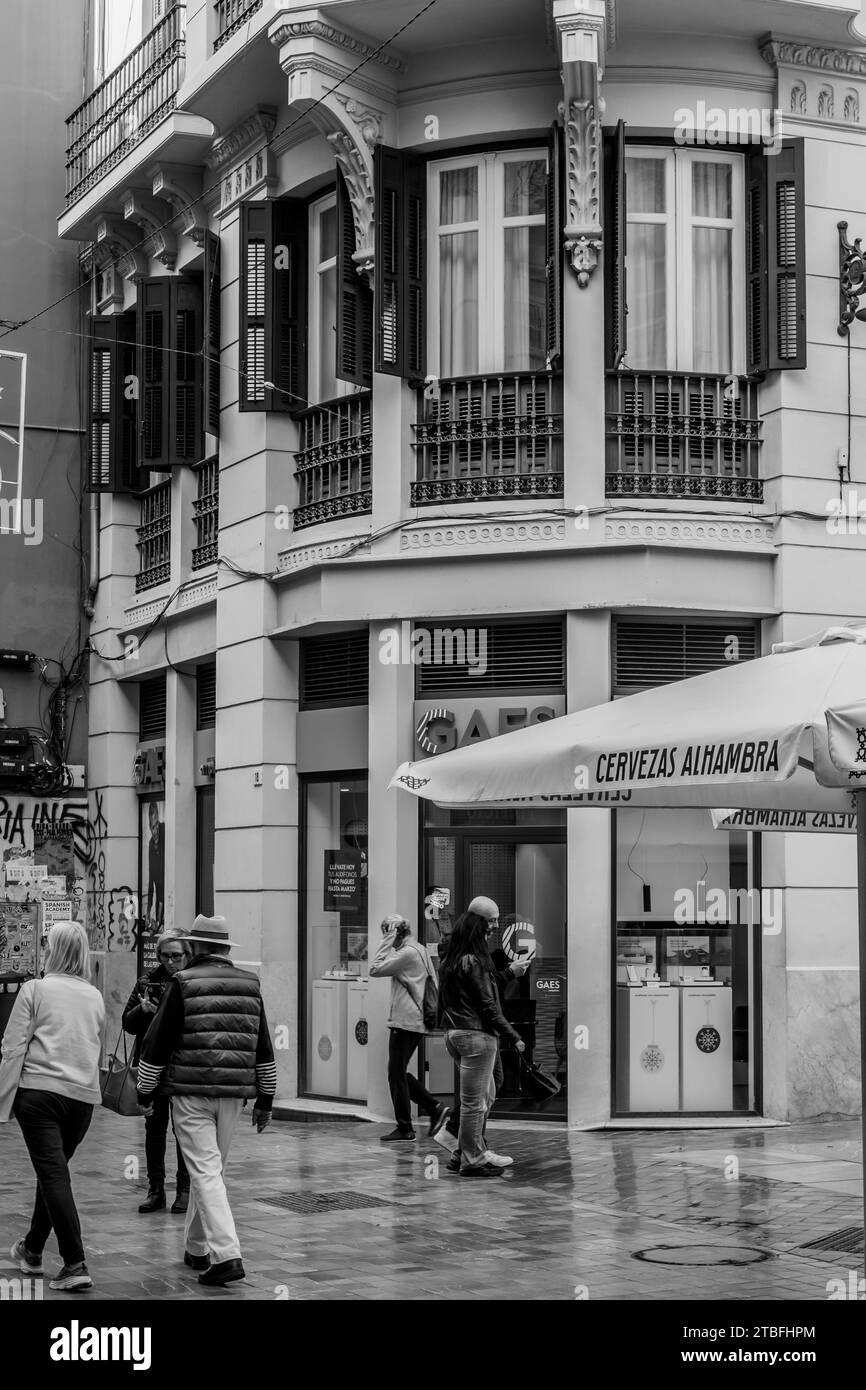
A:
560;64;602;289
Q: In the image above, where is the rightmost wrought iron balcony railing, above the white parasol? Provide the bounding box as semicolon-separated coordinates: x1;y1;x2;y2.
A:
605;371;763;502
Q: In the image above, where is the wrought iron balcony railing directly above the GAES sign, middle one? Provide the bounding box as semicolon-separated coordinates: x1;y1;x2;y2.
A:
411;373;563;507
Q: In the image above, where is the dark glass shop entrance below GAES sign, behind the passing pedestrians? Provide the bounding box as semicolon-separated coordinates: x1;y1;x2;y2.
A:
423;806;569;1119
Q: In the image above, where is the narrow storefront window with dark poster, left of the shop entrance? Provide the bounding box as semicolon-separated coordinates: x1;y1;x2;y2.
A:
302;776;367;1101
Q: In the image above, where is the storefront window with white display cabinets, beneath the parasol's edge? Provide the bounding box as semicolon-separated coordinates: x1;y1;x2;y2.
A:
614;810;756;1115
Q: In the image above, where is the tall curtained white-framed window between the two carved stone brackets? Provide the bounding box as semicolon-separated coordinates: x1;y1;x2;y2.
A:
428;150;548;377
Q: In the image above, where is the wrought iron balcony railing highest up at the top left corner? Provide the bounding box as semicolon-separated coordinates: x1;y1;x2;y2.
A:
67;4;186;207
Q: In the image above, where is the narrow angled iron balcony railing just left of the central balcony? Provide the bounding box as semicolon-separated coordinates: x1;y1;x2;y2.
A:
293;391;373;531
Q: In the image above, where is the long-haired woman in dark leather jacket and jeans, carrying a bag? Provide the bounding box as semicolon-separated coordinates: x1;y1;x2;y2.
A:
439;912;524;1177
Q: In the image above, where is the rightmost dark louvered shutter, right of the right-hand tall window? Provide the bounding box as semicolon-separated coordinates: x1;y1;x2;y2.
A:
763;140;806;370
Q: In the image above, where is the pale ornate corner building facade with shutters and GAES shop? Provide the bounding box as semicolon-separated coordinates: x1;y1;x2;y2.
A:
60;0;866;1125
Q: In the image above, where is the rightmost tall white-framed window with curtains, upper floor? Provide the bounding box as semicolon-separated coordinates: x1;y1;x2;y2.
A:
626;147;745;373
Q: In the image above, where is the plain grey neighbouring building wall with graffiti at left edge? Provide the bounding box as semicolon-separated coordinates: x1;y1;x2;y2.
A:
0;0;91;989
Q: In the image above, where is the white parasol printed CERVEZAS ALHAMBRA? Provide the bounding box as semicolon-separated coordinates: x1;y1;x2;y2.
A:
391;626;866;1234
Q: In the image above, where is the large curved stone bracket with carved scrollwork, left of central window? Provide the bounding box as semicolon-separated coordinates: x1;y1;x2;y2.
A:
270;11;405;285
